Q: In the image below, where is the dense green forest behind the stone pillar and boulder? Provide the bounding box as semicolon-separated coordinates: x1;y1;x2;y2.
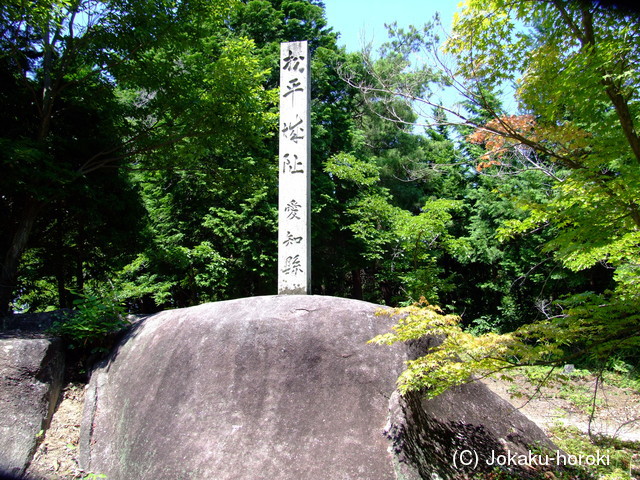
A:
0;0;640;374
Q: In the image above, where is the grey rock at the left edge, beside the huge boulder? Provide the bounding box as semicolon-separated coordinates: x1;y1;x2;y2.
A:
0;333;64;477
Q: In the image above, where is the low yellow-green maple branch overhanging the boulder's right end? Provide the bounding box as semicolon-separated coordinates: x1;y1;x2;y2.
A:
372;290;638;406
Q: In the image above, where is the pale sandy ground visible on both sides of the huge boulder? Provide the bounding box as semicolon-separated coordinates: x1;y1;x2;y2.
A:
26;376;640;480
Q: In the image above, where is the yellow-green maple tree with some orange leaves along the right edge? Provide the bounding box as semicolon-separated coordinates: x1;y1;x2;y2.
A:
448;0;640;338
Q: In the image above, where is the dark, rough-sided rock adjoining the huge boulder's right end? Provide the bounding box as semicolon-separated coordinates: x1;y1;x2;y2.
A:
385;381;557;480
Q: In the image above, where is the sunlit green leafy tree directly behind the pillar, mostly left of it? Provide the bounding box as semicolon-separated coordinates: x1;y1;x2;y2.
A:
98;0;350;311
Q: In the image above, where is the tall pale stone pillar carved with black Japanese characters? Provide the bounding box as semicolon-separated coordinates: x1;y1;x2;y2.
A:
278;42;311;295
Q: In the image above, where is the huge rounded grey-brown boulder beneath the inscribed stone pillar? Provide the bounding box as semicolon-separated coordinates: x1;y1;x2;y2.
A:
80;296;556;480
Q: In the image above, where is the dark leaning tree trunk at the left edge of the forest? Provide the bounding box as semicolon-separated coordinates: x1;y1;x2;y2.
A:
0;198;42;315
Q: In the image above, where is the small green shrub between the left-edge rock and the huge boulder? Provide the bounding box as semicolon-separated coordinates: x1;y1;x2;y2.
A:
50;295;129;350
